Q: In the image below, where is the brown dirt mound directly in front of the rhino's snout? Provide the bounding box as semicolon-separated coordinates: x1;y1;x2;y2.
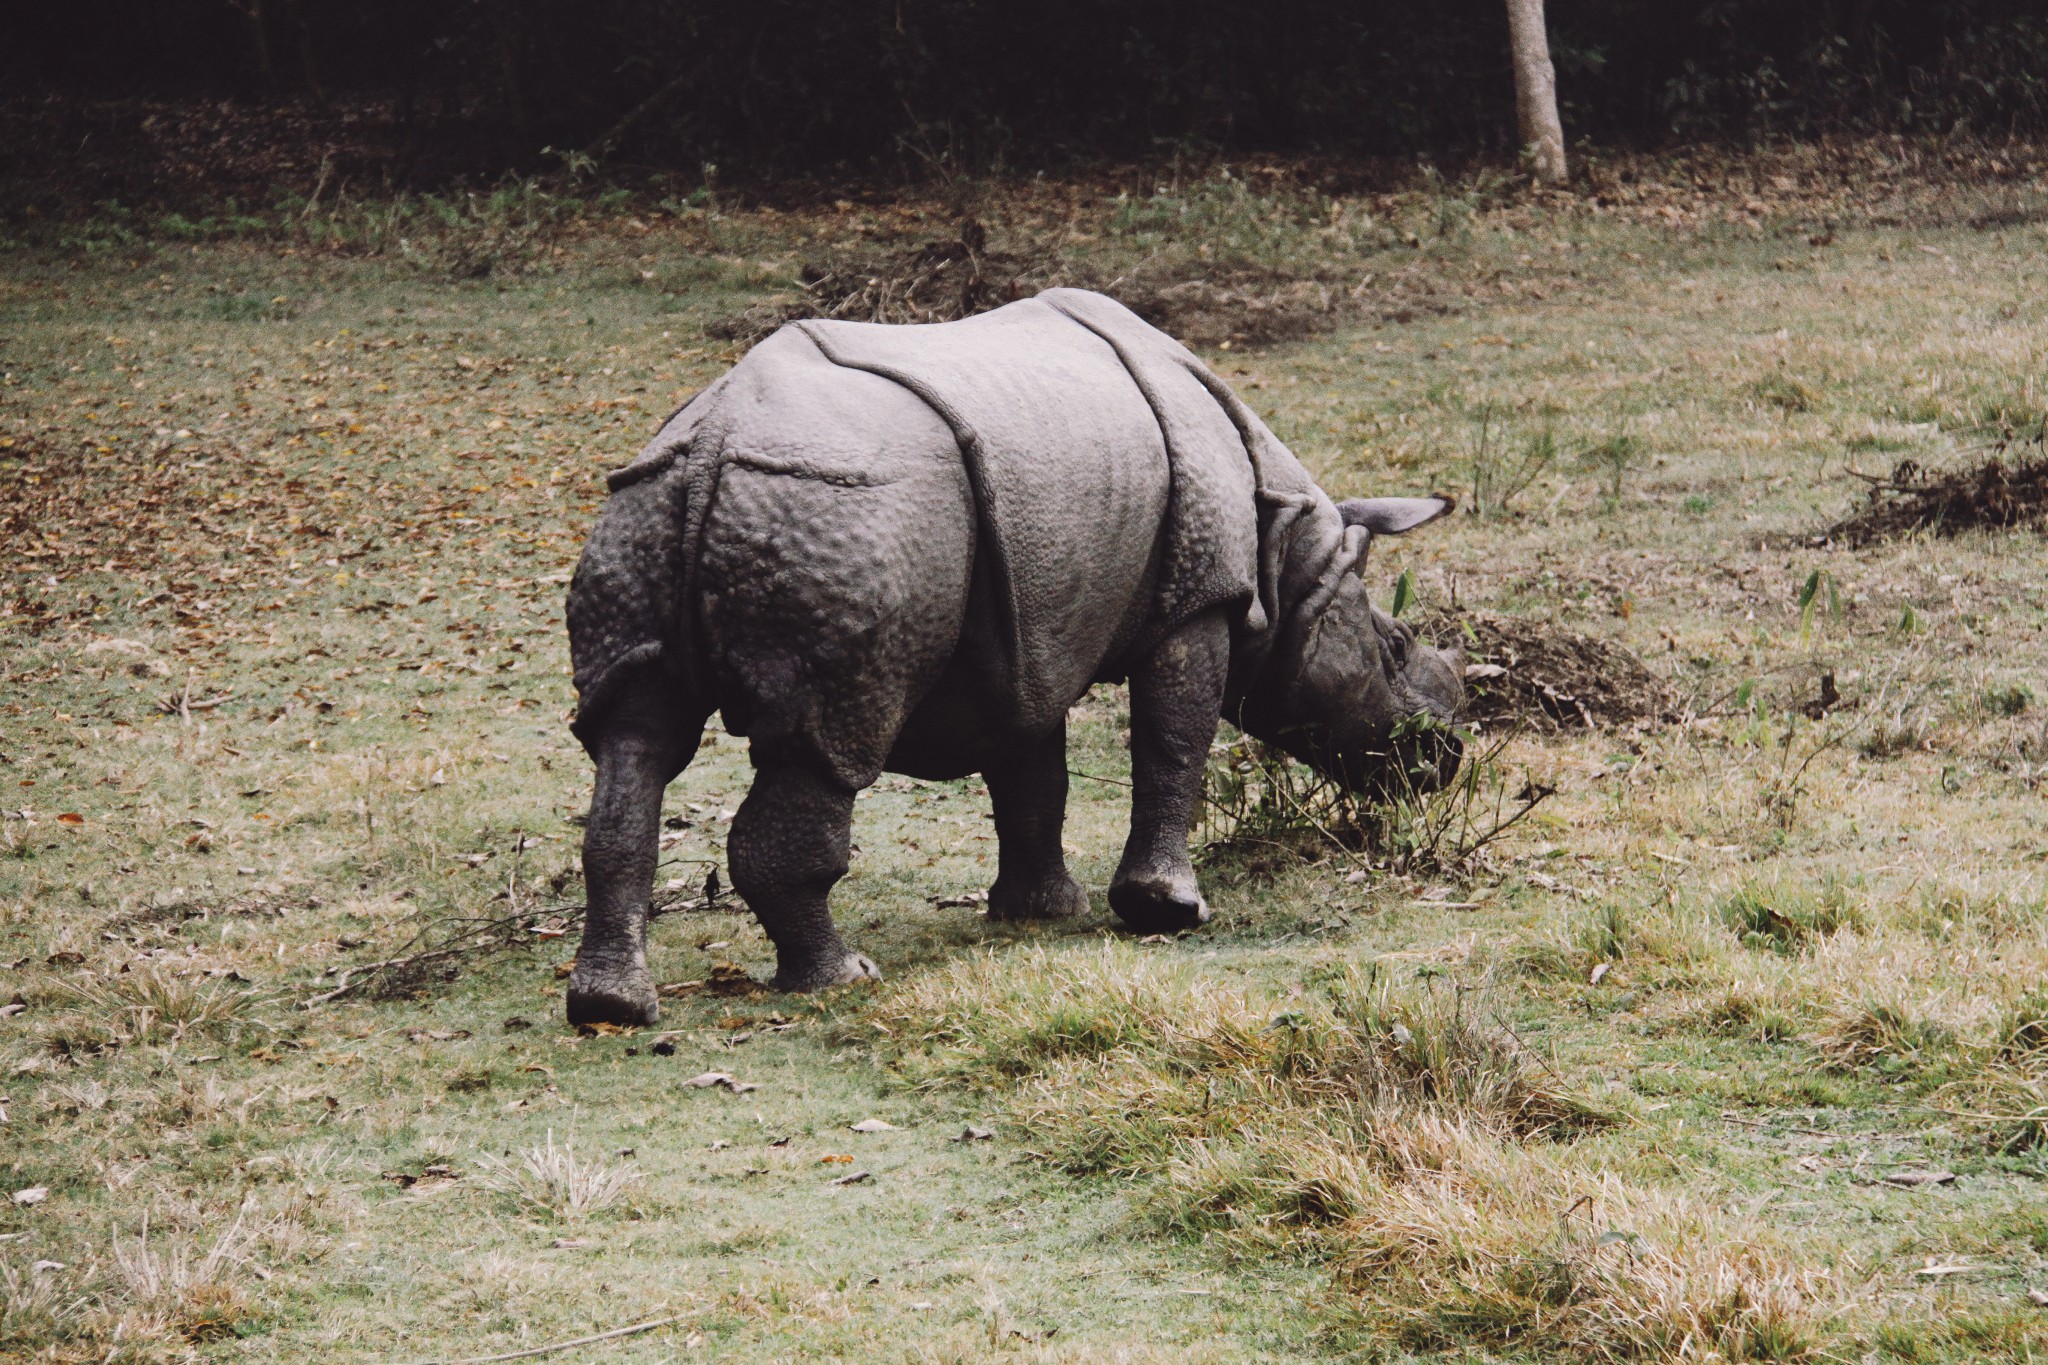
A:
1432;614;1679;733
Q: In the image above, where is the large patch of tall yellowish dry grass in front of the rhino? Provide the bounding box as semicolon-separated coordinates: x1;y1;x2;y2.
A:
881;945;1875;1361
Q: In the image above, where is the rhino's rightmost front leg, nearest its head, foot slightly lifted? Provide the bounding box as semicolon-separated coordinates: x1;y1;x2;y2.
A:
1110;612;1231;933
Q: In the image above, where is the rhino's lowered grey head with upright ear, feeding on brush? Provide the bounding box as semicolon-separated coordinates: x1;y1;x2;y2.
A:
1243;497;1464;792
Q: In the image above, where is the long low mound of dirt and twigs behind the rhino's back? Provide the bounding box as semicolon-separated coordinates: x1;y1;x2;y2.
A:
705;221;1454;346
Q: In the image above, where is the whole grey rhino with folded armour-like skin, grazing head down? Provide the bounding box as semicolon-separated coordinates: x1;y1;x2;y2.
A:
552;289;1464;1023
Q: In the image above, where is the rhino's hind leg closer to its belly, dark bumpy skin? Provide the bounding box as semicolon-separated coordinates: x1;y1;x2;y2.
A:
725;751;881;990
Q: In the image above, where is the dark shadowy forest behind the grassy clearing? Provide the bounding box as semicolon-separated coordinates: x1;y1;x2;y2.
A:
0;0;2048;204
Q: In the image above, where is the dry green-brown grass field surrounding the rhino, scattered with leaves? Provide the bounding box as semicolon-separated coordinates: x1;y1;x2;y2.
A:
0;154;2048;1363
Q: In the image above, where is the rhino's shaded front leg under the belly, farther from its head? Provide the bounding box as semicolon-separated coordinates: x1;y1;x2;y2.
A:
981;718;1087;919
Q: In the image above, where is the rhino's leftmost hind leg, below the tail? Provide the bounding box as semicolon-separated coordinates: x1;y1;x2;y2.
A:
569;690;702;1023
